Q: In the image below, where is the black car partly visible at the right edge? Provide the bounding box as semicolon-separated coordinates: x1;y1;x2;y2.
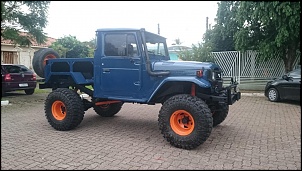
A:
264;68;301;102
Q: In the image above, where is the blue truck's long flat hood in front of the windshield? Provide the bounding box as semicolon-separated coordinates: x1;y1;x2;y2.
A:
152;60;221;71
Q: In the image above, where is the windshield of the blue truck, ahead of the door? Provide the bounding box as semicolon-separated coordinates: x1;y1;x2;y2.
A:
145;32;168;56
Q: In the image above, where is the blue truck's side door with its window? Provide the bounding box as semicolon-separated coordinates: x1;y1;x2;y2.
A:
100;33;141;98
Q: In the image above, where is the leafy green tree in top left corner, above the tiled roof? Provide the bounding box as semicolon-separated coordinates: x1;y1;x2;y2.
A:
1;1;50;45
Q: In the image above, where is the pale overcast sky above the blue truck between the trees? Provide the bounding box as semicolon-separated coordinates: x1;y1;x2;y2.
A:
44;1;218;46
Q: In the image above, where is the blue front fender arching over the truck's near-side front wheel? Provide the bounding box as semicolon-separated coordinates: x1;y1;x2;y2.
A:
148;76;211;102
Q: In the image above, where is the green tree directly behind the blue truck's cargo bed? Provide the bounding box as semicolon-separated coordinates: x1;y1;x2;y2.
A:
50;35;91;58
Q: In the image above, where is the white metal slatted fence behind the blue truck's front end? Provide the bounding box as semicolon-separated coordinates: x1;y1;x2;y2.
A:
212;51;301;90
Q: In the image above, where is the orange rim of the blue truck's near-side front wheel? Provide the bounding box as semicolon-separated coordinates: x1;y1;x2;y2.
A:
170;110;194;135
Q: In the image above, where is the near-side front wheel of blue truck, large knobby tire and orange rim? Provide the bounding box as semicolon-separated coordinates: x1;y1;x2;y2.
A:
158;94;213;150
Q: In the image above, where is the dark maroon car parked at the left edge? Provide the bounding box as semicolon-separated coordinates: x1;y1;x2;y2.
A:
1;64;37;96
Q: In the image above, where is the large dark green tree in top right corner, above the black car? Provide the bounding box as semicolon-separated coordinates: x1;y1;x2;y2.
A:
234;1;301;72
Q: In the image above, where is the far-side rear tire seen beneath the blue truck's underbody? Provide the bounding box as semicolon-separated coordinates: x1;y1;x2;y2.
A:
93;102;124;117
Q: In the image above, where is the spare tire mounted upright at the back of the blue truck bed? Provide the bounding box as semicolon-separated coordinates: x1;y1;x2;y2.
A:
32;48;60;78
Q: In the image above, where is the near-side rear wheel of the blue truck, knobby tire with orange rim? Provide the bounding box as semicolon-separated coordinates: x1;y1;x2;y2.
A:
44;88;84;131
